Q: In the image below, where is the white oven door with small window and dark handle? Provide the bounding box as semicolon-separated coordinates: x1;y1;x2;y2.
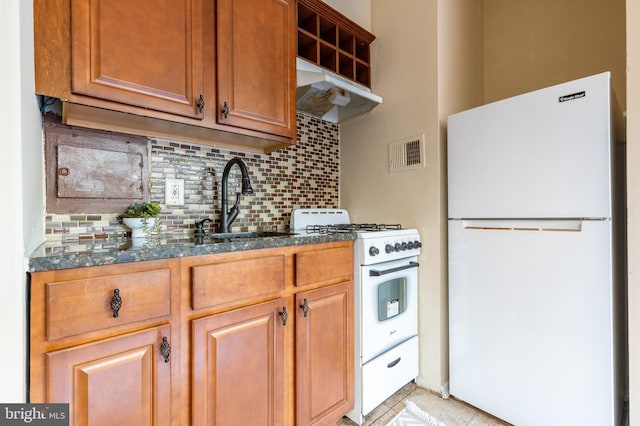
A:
360;257;418;364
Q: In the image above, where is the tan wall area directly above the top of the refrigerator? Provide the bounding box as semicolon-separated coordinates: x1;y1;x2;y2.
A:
484;0;626;111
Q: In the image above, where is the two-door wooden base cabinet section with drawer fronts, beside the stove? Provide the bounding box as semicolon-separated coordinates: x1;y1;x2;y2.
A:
182;241;354;426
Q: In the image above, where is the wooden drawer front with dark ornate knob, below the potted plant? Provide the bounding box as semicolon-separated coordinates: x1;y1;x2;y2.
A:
46;269;171;340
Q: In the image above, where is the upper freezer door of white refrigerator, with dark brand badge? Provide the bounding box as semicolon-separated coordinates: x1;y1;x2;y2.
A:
447;73;611;218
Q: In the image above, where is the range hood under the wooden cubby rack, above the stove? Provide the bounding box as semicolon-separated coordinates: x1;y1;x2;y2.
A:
296;58;382;123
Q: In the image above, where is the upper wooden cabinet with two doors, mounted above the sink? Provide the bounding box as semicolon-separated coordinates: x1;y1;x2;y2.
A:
34;0;296;152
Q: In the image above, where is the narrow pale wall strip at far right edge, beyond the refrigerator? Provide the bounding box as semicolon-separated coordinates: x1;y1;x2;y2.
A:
627;0;640;426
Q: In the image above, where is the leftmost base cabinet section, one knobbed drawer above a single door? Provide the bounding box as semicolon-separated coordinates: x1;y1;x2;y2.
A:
29;259;180;426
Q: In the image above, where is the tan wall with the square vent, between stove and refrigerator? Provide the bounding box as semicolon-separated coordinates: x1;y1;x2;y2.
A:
340;0;446;391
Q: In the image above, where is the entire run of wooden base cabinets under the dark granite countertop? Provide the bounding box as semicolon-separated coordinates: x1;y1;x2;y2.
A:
29;241;354;426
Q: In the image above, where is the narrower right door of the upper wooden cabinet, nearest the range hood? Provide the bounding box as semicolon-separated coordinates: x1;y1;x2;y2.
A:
217;0;296;137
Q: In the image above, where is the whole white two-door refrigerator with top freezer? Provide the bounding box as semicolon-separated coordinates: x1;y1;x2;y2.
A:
447;72;624;426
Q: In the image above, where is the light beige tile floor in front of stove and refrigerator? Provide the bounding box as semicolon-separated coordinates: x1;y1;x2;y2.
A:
334;382;509;426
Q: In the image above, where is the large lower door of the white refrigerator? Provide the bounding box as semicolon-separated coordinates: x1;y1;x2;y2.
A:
449;220;615;426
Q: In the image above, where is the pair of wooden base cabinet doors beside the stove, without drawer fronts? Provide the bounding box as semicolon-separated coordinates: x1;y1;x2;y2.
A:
193;281;353;425
